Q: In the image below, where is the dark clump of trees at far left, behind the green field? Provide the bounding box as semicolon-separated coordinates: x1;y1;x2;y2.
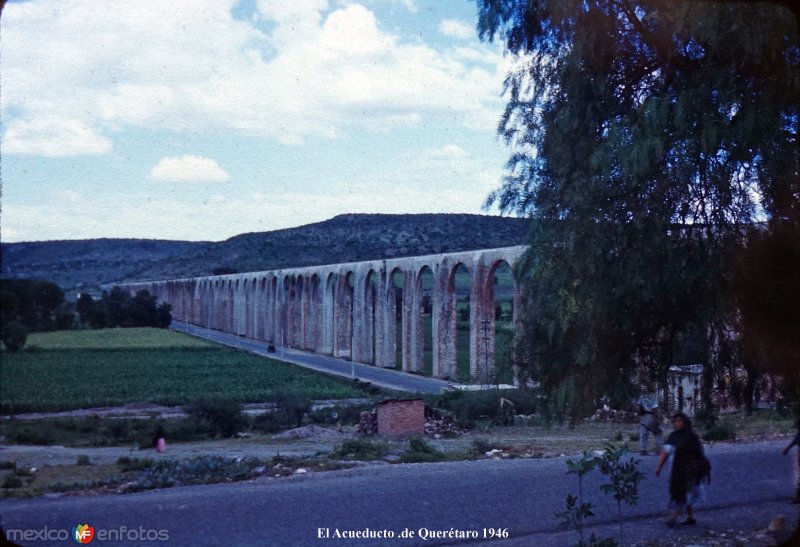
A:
0;279;172;351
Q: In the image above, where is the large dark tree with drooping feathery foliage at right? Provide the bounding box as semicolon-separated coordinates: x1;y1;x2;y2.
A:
477;0;800;420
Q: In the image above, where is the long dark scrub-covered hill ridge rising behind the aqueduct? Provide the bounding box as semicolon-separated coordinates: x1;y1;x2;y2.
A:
1;214;528;292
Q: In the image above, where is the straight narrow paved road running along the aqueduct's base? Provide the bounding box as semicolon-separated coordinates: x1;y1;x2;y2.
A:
170;321;452;393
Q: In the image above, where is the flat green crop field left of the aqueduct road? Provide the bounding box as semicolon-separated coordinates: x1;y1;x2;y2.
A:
0;329;363;414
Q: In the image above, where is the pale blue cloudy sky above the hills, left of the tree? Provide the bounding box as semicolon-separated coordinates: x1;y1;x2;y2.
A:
0;0;509;242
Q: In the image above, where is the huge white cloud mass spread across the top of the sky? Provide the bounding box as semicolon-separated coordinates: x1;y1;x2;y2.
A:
0;0;503;154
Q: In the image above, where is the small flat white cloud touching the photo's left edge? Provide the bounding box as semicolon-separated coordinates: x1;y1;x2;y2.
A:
2;118;112;158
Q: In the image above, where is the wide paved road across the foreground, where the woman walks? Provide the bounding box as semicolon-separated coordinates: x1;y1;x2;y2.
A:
0;441;797;547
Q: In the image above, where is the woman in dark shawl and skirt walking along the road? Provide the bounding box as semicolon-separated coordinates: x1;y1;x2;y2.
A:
656;413;711;527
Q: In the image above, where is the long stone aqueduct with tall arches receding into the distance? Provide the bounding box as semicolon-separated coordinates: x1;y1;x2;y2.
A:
126;246;524;379
